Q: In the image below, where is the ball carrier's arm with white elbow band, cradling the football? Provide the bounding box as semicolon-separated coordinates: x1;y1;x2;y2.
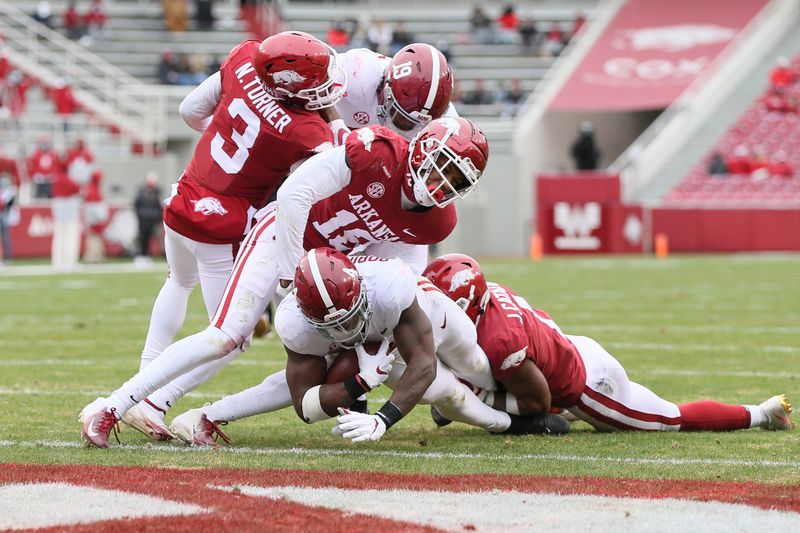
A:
284;347;354;424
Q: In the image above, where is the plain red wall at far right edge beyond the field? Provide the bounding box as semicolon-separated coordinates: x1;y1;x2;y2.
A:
652;208;800;252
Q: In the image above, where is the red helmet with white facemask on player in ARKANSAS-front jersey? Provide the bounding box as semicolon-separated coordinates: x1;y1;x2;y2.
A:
404;117;489;207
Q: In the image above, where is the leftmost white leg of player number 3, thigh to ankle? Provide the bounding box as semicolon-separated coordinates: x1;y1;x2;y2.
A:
139;225;199;370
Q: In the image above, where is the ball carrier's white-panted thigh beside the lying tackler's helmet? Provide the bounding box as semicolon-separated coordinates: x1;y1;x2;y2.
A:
425;290;497;390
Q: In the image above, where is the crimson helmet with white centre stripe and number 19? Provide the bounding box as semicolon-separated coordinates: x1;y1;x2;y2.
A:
378;43;453;138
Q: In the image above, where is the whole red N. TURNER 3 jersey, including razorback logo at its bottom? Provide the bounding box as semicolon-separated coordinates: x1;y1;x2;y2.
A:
164;41;333;244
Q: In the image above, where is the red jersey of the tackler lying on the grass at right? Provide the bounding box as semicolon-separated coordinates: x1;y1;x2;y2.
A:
477;283;586;407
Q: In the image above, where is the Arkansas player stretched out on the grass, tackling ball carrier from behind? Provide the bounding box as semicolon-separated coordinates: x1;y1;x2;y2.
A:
424;254;794;431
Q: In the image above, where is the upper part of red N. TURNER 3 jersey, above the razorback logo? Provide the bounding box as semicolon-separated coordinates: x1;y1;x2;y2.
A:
184;40;333;209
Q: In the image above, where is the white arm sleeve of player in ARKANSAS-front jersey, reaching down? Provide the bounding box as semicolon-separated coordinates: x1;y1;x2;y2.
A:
275;147;350;280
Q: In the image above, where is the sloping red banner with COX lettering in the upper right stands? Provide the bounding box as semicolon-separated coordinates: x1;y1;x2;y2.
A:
550;0;768;111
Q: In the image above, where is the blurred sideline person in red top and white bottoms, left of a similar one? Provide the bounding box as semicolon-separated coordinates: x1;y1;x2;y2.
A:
50;165;81;272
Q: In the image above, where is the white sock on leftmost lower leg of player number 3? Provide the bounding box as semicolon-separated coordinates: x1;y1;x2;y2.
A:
139;278;192;370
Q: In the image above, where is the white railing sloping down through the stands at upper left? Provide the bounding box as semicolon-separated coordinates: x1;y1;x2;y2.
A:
0;1;167;147
